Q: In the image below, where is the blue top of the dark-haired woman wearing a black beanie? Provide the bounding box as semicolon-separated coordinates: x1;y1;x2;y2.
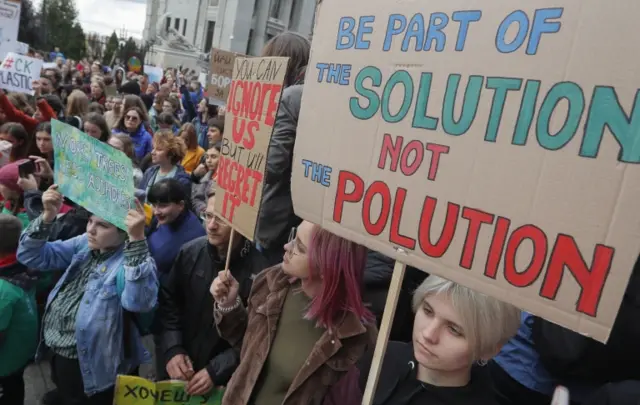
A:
147;209;207;277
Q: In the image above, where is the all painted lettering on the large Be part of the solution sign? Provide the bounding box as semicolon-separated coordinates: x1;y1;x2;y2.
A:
296;8;640;317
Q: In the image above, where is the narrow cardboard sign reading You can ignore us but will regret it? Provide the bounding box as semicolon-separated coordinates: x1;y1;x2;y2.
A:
215;58;289;240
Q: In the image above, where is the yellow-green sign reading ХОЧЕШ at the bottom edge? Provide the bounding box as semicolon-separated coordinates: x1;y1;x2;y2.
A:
113;375;224;405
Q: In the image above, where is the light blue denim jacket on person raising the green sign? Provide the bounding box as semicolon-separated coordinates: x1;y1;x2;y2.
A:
18;217;158;396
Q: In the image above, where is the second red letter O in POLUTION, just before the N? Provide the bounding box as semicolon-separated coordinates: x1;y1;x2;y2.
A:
504;225;547;287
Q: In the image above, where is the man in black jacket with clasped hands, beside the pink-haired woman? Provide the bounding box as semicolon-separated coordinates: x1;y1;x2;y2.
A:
157;191;275;395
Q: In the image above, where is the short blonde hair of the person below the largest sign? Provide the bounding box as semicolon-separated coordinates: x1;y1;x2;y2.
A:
412;276;521;361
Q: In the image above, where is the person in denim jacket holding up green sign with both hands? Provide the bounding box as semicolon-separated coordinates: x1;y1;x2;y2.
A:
17;185;158;405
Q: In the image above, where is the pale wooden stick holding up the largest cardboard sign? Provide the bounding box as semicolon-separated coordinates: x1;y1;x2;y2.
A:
362;260;407;405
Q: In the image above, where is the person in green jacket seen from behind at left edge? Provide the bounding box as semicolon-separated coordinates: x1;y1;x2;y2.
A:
0;214;38;405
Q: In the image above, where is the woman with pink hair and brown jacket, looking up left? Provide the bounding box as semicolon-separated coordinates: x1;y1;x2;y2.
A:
211;221;377;405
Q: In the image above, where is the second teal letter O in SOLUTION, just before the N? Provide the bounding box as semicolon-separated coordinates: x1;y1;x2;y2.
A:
536;82;585;150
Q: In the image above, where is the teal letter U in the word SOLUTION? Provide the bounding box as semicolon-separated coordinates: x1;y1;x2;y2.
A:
442;74;484;136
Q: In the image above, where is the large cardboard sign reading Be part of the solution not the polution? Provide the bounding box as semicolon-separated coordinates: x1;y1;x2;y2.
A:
292;0;640;341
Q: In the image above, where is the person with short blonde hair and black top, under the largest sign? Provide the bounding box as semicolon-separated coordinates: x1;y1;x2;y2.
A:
324;276;520;405
